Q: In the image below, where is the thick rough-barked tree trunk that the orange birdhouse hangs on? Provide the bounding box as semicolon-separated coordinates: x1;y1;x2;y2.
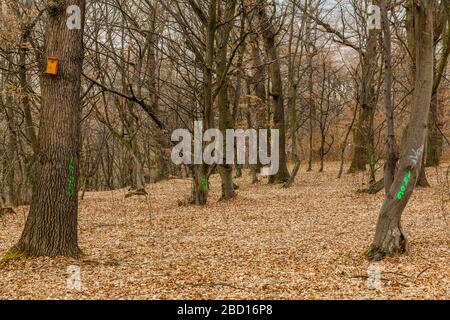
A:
9;0;85;258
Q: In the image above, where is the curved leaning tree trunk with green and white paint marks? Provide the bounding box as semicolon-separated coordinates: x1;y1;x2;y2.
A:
366;0;434;260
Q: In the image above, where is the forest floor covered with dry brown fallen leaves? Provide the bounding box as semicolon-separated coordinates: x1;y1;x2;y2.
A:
0;163;450;299
